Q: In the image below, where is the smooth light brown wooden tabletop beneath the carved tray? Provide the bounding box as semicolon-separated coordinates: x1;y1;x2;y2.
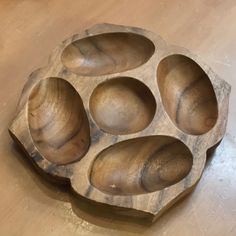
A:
0;0;236;236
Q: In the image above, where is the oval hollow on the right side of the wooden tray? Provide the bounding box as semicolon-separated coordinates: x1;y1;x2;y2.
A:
157;54;218;135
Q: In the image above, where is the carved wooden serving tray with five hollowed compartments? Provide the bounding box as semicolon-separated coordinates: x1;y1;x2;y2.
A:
9;24;230;220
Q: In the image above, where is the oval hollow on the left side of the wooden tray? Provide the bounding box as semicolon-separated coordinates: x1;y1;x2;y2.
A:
28;78;90;164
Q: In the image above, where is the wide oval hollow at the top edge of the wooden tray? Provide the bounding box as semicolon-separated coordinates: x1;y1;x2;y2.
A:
61;32;155;76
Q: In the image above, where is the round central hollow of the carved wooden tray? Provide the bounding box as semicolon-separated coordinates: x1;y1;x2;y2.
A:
90;77;156;134
